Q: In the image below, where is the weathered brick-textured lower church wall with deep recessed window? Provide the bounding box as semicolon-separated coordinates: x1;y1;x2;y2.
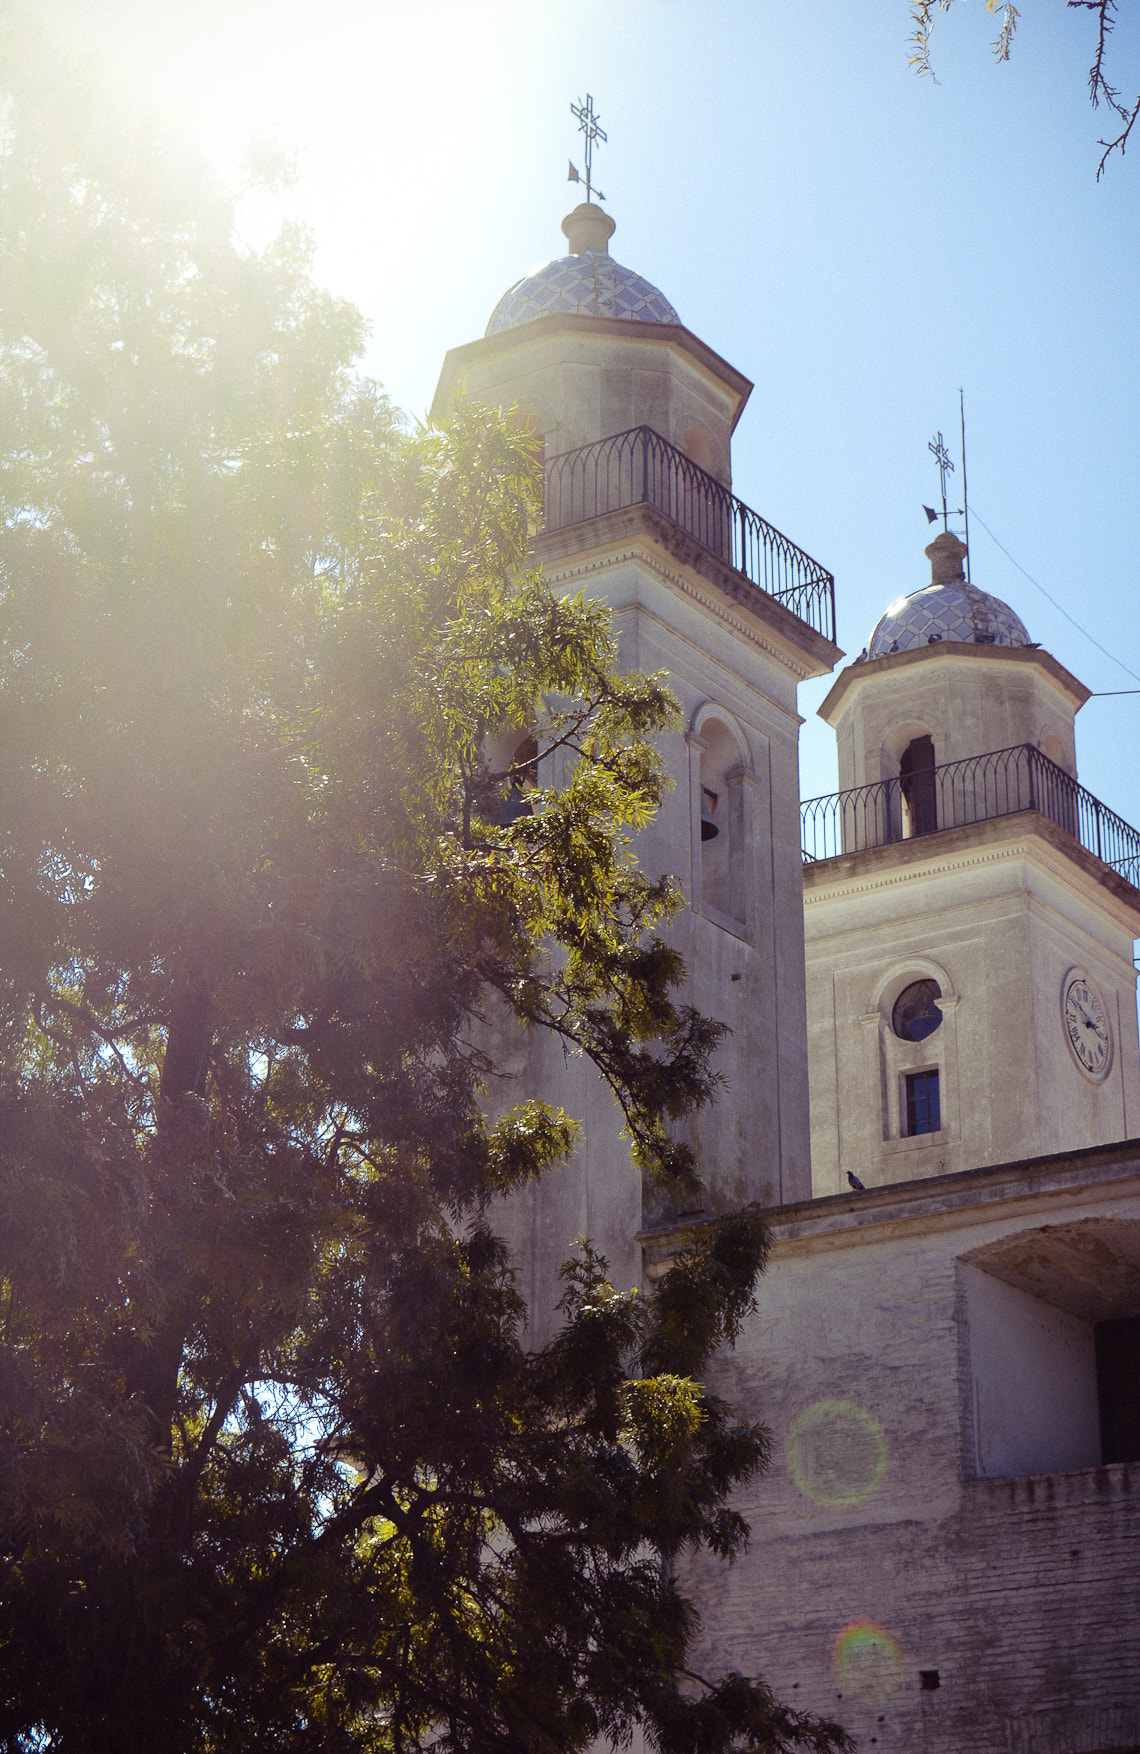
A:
647;1142;1140;1754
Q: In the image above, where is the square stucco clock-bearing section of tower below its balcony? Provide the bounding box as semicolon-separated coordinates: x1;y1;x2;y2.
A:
803;810;1140;1194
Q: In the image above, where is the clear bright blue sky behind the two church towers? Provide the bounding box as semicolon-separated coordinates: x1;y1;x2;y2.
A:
51;0;1140;826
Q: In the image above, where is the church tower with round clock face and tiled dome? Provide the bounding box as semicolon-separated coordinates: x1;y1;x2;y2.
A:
803;531;1140;1194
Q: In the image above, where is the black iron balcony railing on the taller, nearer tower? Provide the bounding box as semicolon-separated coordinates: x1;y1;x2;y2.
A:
545;426;835;640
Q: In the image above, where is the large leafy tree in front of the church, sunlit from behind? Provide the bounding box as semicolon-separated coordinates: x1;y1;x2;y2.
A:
0;18;847;1754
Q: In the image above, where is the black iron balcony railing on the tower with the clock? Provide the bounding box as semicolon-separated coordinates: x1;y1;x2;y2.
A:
800;744;1140;888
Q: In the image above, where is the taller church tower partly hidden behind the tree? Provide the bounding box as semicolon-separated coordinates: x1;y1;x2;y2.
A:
433;202;840;1337
